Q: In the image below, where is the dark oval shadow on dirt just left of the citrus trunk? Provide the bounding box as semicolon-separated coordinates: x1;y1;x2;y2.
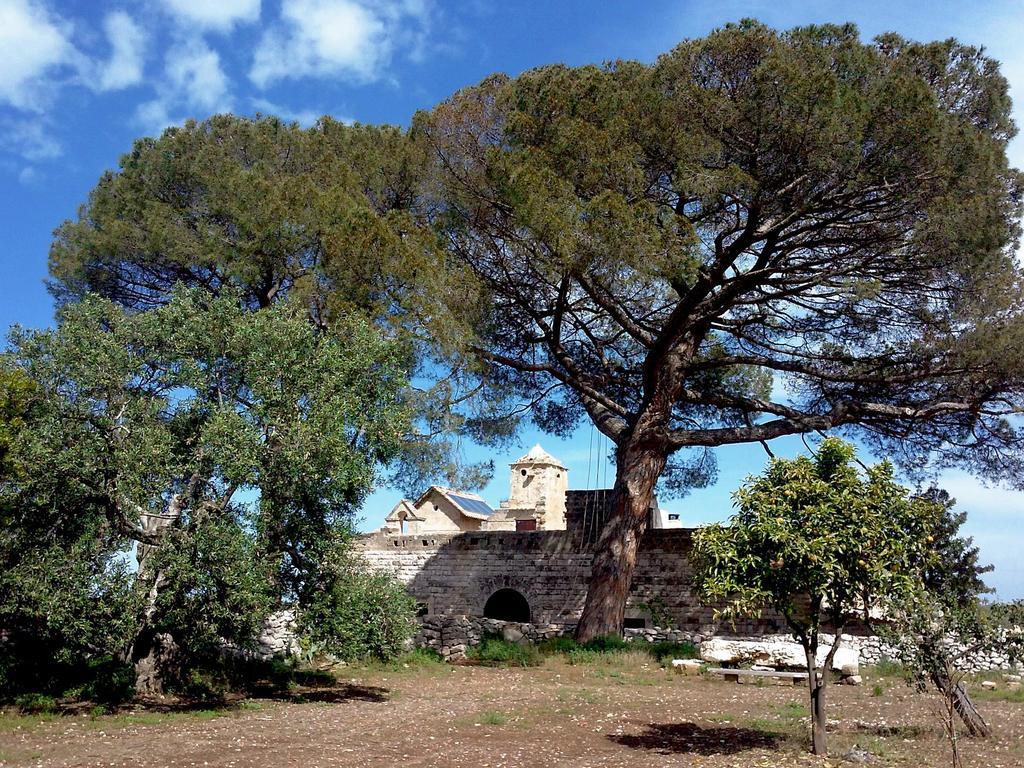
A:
608;723;781;756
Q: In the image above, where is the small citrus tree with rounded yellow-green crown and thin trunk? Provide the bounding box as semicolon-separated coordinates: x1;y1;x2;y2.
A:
694;438;936;755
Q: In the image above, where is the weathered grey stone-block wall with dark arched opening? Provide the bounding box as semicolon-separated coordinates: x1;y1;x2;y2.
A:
358;524;784;635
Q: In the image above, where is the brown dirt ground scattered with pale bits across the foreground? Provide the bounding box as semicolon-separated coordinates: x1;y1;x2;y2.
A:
0;654;1024;768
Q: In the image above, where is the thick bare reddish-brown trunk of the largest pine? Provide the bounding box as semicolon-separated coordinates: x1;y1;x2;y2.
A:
575;440;667;642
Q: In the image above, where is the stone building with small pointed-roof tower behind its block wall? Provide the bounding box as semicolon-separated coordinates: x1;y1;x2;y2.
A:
359;445;779;633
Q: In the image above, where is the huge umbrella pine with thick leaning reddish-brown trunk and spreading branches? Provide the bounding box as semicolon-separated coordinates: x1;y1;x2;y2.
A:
414;22;1024;639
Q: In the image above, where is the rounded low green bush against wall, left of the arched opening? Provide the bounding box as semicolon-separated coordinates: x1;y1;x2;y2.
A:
300;545;416;660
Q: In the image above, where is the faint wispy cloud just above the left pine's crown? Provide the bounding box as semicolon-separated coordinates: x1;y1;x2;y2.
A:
135;39;232;133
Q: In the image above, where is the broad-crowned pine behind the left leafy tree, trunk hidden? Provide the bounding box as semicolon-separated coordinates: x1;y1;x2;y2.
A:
50;115;501;494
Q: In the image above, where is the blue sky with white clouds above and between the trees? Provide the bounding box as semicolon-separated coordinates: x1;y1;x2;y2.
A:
0;0;1024;598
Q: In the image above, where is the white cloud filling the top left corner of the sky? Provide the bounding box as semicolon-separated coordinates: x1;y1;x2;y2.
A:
0;0;78;112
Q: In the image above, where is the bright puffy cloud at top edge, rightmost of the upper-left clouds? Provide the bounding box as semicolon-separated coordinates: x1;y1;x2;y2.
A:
249;0;428;87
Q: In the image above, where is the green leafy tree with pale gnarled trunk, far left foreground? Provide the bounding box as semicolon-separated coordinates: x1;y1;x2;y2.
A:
3;289;409;691
